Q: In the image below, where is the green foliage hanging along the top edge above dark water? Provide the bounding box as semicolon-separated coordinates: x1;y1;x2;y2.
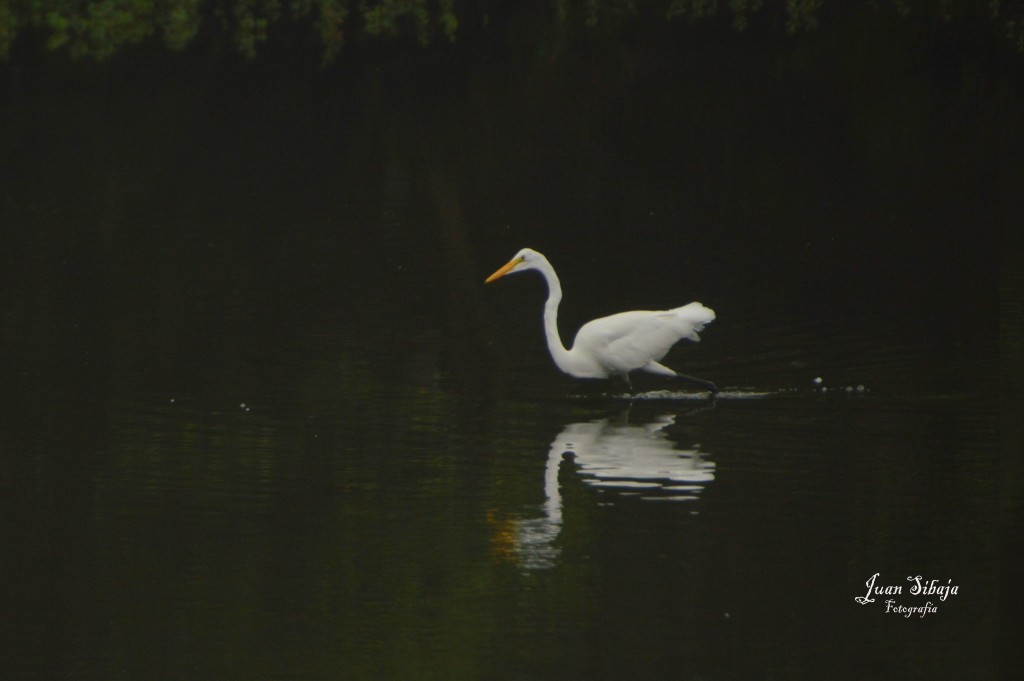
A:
0;0;1024;61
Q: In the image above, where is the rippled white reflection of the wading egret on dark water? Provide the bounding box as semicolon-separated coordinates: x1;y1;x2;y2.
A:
510;415;715;569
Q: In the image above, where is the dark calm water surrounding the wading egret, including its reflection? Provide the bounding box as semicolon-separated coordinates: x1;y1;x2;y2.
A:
0;15;1024;680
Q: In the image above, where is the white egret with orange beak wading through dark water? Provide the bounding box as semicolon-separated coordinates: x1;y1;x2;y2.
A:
484;248;718;395
